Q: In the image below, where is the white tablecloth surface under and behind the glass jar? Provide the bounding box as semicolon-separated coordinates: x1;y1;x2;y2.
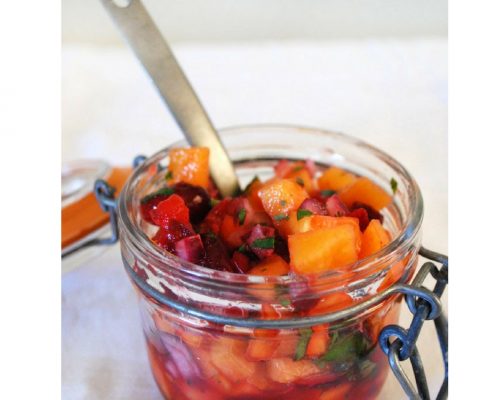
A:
62;39;447;399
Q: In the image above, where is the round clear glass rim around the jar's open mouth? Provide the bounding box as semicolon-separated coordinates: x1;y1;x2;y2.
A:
117;124;423;288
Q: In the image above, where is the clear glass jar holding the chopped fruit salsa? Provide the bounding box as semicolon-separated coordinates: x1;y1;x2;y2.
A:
118;126;423;400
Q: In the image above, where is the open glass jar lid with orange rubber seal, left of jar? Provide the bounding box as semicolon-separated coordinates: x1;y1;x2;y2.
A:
61;160;132;260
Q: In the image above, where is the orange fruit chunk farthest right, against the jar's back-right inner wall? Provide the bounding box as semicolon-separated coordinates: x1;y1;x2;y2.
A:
339;178;392;210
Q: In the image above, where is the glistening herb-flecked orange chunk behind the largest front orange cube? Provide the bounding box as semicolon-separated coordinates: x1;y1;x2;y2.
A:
258;179;309;220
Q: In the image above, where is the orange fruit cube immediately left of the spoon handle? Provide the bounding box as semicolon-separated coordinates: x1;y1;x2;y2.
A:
168;147;210;189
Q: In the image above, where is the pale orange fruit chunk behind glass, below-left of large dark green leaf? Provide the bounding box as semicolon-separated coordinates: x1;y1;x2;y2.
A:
266;358;320;383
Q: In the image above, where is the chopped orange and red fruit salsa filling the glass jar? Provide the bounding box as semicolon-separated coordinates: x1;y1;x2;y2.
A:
136;147;412;400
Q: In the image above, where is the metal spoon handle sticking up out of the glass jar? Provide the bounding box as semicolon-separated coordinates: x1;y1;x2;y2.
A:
101;0;239;196
